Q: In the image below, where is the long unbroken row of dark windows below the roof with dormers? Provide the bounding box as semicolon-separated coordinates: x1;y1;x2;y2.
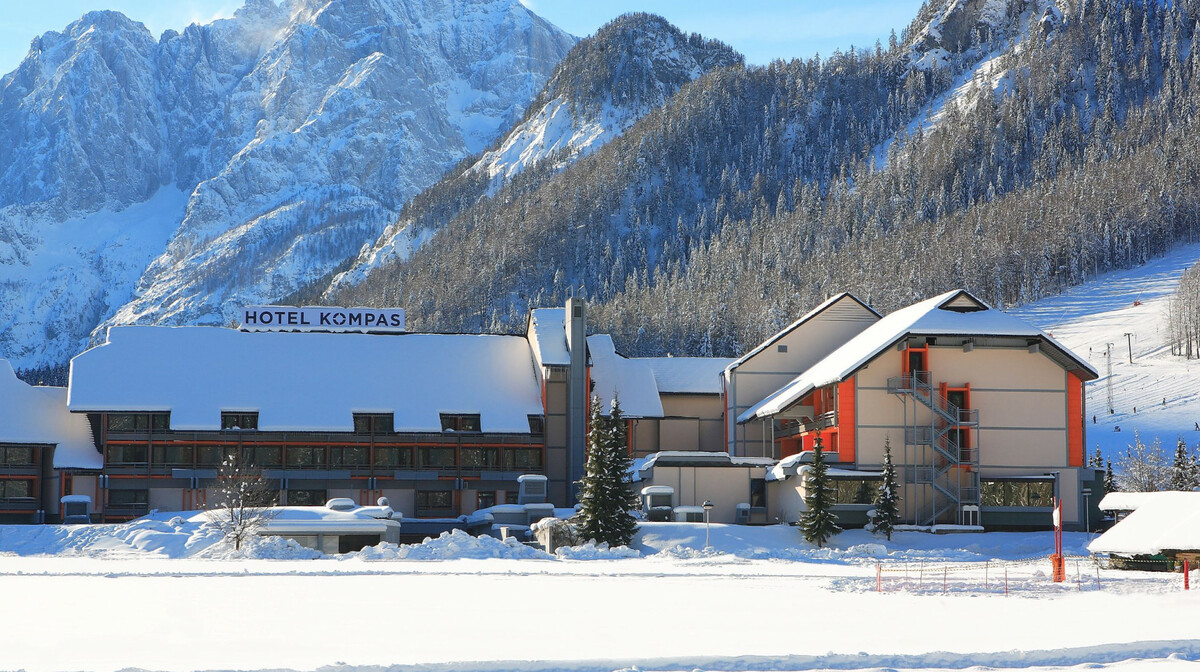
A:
107;444;542;470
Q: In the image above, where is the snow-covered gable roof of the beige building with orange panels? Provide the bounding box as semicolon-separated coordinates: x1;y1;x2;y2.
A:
738;289;1098;422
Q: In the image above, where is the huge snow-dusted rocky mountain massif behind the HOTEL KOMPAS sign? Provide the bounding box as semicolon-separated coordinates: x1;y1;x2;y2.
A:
0;0;575;367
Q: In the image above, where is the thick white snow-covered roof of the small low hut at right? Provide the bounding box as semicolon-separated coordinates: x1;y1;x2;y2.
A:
1087;492;1200;556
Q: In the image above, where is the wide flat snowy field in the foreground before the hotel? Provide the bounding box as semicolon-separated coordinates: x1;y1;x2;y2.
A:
0;520;1200;672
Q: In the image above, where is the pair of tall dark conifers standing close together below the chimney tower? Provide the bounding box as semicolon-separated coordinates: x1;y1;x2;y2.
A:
575;397;638;546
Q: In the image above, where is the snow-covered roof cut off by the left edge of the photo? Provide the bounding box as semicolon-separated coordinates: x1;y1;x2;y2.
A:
0;359;104;469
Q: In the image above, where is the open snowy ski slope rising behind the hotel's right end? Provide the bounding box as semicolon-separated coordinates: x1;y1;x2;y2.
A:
1013;245;1200;461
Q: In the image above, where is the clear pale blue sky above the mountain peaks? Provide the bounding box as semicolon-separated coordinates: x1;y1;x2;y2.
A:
0;0;920;73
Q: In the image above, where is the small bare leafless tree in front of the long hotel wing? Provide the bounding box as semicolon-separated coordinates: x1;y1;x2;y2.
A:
208;450;276;550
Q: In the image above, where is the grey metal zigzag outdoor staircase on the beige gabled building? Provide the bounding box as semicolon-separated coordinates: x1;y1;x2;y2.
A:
888;371;979;524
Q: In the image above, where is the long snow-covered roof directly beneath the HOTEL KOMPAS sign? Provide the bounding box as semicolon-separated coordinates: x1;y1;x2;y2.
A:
68;326;542;433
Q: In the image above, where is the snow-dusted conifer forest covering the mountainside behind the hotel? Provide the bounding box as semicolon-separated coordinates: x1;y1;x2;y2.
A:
326;0;1200;355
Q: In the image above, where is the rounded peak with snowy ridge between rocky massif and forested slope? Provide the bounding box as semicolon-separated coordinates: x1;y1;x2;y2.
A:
326;13;743;291
